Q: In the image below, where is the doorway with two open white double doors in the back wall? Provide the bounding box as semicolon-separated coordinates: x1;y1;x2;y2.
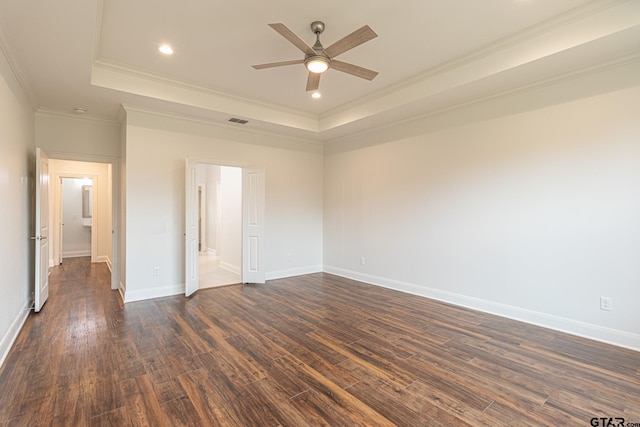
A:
184;158;266;297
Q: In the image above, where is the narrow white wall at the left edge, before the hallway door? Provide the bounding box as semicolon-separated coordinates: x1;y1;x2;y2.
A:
0;45;35;365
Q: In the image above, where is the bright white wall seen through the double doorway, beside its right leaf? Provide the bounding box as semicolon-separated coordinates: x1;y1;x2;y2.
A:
218;166;242;274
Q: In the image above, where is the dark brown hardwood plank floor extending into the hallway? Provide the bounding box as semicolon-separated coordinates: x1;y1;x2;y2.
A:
0;258;640;427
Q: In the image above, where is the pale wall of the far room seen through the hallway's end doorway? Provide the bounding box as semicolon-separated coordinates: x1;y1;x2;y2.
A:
61;178;91;258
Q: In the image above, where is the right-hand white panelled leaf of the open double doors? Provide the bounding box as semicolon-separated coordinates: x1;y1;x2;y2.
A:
242;167;265;283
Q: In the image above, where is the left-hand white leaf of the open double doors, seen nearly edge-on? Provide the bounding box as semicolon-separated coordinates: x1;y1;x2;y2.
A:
184;159;198;296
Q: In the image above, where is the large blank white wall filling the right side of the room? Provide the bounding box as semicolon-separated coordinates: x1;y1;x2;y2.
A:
324;83;640;349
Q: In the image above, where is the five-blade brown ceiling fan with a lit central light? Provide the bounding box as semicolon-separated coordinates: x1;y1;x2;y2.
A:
253;21;378;91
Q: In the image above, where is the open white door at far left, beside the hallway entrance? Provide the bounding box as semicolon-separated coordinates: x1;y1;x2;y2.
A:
32;148;49;312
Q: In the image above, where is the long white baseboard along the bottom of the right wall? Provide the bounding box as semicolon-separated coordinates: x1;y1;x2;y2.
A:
324;265;640;351
